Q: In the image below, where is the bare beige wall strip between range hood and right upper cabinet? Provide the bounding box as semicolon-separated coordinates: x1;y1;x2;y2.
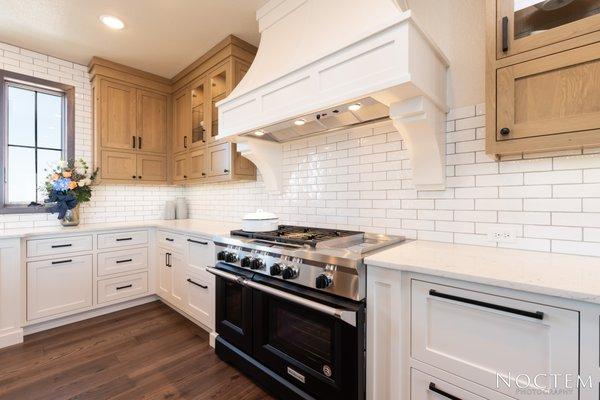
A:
407;0;485;108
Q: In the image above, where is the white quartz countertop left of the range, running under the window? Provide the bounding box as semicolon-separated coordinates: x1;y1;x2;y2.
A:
0;219;241;239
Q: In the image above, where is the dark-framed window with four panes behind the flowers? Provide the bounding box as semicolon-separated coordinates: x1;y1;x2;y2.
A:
0;70;74;213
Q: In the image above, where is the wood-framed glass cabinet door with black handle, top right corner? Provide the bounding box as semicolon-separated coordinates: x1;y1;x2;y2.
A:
496;0;600;58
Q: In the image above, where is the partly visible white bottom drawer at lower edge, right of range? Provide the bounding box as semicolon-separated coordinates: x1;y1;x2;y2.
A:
410;368;512;400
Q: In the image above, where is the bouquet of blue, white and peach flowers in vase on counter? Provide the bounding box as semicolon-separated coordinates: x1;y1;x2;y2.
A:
44;158;98;226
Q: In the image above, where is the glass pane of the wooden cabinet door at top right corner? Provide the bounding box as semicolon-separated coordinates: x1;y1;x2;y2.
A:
514;0;600;39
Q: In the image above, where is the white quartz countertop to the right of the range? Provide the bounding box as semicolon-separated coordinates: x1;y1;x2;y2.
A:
365;240;600;304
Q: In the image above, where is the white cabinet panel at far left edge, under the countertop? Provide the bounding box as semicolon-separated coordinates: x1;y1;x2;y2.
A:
0;239;24;348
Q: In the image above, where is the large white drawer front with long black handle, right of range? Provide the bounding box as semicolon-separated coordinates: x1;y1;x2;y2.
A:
411;279;579;399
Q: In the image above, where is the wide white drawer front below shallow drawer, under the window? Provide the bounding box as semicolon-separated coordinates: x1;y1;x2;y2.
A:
27;255;93;320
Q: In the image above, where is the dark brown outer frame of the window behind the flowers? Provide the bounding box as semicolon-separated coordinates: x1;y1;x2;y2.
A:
0;69;75;214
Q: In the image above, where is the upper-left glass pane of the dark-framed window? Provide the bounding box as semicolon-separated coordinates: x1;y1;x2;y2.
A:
8;86;35;146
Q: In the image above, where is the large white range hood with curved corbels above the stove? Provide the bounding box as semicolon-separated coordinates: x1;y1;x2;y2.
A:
217;0;448;191
